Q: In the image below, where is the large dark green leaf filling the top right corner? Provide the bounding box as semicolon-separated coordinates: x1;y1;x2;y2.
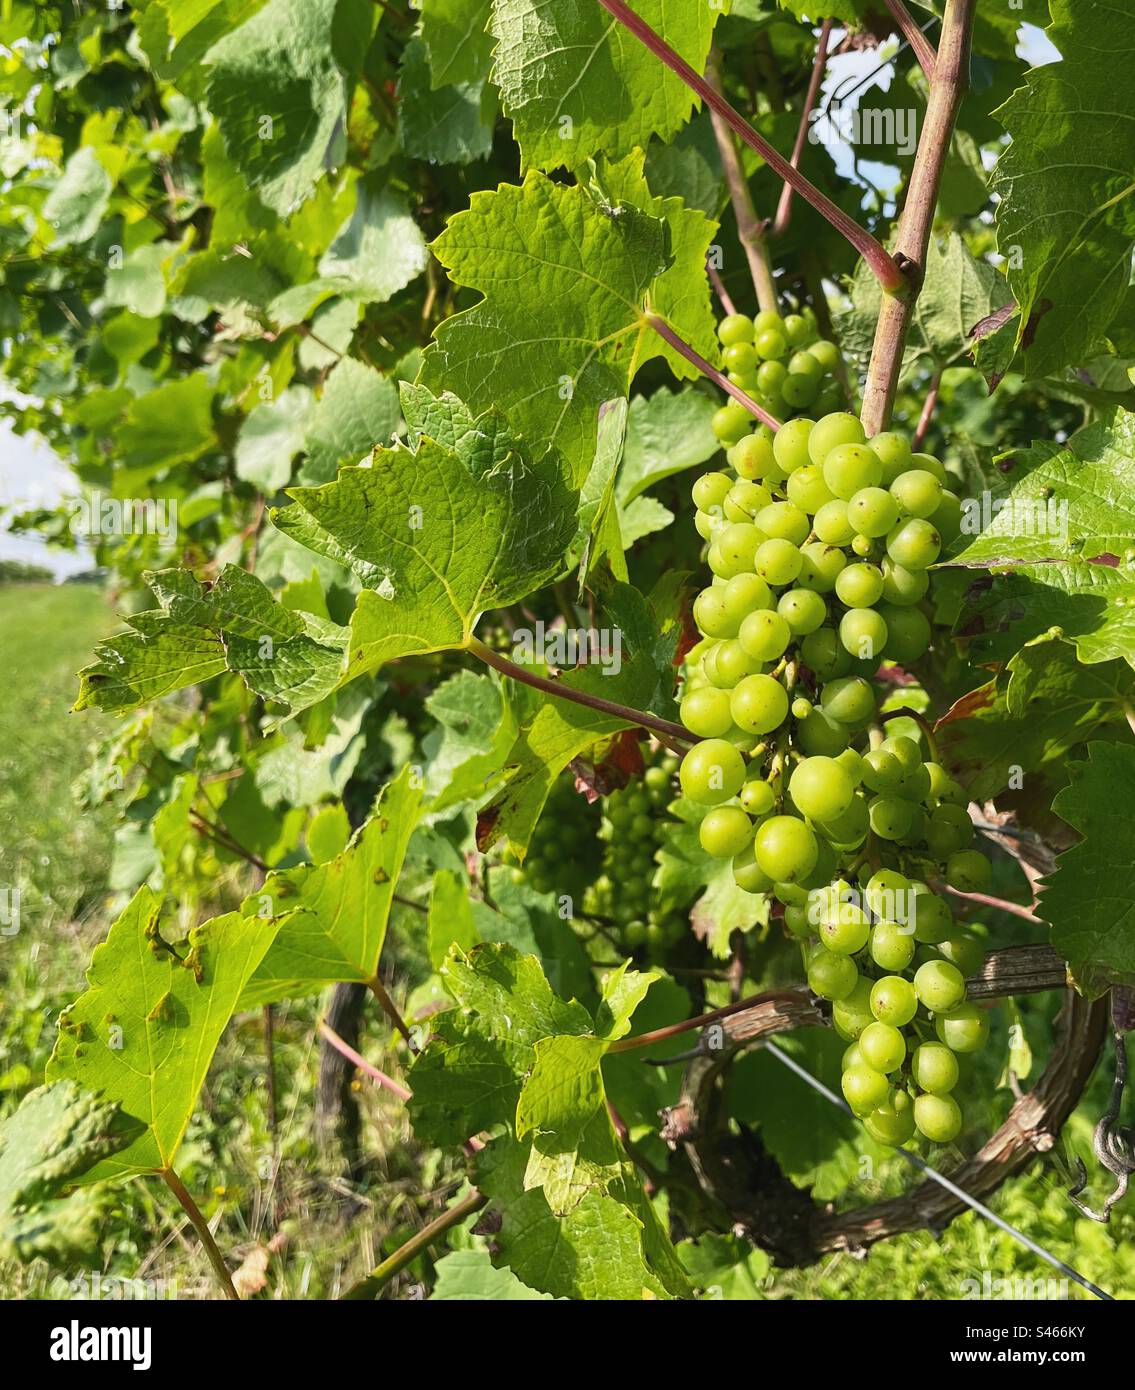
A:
992;0;1135;378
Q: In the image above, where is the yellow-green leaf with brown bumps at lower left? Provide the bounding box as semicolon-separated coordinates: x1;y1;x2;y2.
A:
47;887;278;1180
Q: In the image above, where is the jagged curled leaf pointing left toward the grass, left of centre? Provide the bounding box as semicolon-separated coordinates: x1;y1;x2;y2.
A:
75;564;346;712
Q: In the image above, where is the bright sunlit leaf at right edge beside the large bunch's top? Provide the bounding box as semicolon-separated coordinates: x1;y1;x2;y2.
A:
942;407;1135;664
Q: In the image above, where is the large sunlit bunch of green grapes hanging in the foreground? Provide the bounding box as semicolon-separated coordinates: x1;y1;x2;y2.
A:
679;413;991;1144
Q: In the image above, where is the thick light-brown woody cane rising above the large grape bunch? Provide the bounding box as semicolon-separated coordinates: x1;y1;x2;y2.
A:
861;0;977;438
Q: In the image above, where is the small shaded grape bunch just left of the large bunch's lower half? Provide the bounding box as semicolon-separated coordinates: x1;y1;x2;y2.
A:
583;749;689;956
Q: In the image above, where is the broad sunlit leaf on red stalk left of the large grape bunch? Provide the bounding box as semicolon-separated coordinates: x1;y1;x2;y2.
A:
272;389;575;678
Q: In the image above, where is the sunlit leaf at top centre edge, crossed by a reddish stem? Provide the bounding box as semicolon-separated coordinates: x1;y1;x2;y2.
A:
492;0;720;170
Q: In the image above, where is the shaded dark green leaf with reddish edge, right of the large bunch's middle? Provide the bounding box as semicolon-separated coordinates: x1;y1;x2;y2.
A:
938;635;1135;801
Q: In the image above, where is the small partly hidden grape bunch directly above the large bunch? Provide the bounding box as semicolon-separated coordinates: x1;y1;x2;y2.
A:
713;309;846;445
